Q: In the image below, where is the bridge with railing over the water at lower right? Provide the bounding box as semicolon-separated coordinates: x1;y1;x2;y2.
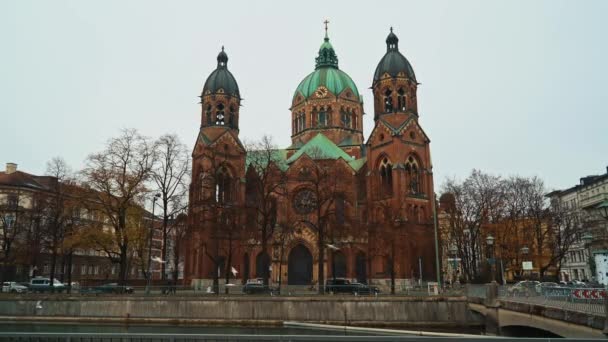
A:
467;283;608;338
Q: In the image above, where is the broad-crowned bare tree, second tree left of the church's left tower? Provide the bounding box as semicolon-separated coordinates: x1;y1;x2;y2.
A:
83;129;155;286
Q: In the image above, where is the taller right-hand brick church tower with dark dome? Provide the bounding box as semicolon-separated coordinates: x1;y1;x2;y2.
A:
366;28;435;277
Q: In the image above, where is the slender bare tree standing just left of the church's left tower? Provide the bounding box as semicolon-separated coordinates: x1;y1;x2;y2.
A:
152;134;190;280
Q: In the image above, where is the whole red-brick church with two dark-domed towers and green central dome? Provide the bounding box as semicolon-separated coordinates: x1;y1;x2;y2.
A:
184;27;436;289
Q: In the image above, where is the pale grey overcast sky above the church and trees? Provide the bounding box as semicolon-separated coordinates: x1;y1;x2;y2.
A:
0;0;608;188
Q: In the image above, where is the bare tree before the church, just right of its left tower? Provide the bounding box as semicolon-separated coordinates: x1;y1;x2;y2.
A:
246;135;287;285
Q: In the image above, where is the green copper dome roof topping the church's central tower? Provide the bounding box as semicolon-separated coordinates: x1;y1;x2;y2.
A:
293;36;360;101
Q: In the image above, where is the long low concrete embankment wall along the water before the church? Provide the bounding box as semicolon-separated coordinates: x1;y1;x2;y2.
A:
0;296;481;326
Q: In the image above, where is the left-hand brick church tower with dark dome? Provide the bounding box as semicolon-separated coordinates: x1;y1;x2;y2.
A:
186;47;246;278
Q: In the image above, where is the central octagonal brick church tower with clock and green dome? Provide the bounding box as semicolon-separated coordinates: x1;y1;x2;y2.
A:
289;22;363;158
